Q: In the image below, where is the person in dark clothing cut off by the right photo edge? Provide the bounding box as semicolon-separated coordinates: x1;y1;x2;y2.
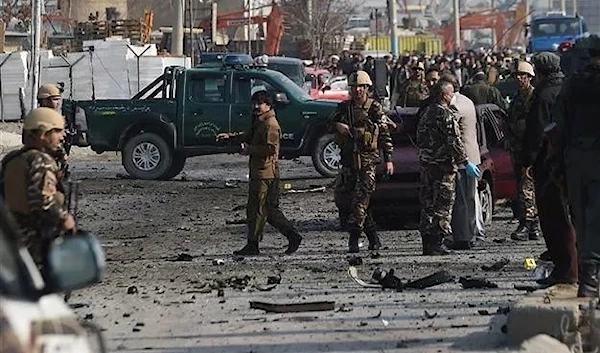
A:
546;36;600;298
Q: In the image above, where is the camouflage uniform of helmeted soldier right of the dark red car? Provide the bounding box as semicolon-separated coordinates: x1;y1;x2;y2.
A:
506;86;537;224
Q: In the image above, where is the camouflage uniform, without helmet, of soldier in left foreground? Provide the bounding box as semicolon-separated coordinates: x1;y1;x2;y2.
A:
2;147;69;267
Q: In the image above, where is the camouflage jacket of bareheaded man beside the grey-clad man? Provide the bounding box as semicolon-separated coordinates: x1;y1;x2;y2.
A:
417;103;467;171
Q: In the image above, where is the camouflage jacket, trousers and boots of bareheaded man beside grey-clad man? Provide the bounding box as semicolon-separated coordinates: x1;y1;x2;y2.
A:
417;103;467;255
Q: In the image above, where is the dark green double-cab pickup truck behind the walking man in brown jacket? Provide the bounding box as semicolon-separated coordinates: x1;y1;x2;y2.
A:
63;59;339;180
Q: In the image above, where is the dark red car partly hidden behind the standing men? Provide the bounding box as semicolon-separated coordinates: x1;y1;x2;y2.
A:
371;104;517;224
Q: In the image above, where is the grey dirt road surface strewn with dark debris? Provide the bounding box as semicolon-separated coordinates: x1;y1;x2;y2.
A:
61;154;543;353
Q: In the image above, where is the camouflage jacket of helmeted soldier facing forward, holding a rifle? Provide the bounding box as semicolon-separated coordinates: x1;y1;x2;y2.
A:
328;98;393;167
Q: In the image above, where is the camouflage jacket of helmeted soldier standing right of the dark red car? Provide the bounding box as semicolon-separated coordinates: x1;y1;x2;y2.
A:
506;86;534;152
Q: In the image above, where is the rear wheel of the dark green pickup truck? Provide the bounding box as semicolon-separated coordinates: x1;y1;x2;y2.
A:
122;133;173;180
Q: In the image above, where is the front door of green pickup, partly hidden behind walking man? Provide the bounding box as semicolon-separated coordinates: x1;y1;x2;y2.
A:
231;72;302;148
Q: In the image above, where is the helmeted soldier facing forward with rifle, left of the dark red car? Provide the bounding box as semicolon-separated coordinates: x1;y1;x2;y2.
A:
328;71;394;253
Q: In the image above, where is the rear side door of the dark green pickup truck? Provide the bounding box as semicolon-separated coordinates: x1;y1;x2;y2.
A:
183;72;231;147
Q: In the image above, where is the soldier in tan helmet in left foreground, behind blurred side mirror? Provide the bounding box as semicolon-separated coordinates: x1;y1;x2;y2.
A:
2;108;75;274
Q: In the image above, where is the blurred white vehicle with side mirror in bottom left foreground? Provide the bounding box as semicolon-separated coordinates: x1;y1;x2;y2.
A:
0;206;105;353
